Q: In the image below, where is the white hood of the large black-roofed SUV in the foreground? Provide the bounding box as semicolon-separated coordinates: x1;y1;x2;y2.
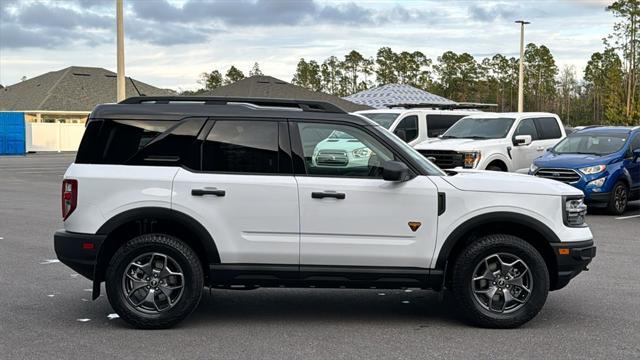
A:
443;170;582;195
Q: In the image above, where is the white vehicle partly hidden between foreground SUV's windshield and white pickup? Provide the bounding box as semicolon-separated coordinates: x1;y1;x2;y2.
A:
355;108;479;146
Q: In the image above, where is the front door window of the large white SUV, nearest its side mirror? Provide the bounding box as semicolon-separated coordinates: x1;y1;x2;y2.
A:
294;122;395;178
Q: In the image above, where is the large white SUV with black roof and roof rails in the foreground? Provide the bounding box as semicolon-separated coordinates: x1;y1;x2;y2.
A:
54;97;595;328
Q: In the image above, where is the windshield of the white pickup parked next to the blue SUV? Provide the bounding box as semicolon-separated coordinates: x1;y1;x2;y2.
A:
442;117;515;139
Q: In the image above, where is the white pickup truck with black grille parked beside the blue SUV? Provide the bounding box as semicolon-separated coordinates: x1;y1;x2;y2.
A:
414;112;565;173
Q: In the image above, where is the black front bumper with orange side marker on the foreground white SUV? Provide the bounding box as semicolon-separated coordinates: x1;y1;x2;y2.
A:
551;240;596;290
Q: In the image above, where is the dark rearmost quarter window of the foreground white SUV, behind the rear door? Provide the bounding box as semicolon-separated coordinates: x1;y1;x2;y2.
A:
76;118;205;167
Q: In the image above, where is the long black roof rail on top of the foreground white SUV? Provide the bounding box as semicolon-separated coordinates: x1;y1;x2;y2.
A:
118;96;346;114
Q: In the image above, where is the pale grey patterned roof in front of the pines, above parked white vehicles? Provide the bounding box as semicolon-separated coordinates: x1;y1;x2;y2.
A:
345;84;456;109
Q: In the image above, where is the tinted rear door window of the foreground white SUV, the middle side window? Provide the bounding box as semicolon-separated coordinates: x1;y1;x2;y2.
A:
202;120;278;174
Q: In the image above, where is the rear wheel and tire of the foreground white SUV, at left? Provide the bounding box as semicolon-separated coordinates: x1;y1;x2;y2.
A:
106;234;204;329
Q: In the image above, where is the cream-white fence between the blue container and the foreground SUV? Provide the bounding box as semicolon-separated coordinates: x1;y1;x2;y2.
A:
25;123;84;151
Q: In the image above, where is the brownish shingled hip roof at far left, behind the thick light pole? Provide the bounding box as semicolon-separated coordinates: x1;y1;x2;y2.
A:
0;66;174;111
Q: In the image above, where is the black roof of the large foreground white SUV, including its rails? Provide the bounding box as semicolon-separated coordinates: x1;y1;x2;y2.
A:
89;96;376;125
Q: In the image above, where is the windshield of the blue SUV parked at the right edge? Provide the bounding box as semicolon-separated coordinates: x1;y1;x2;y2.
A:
553;133;627;155
